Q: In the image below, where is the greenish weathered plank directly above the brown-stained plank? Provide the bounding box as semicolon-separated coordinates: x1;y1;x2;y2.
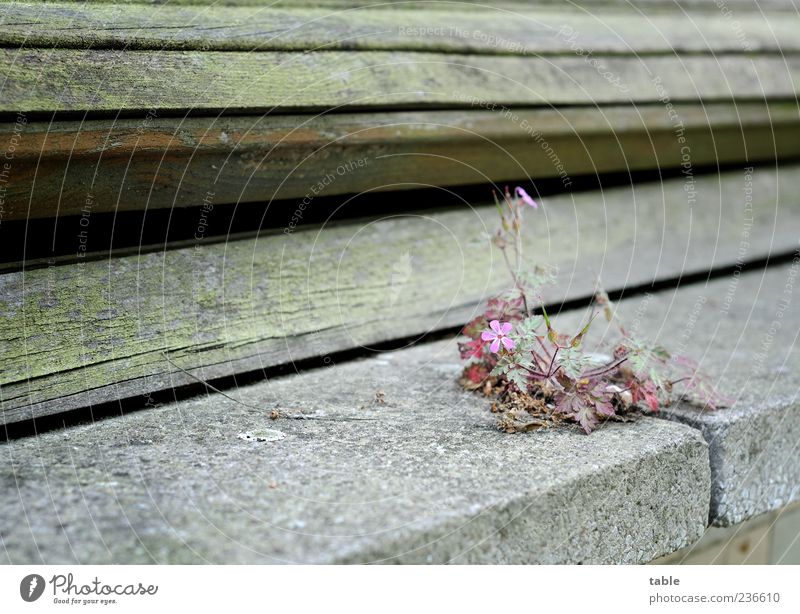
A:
0;49;800;114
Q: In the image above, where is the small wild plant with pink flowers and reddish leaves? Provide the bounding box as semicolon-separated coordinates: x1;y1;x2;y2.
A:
459;187;723;433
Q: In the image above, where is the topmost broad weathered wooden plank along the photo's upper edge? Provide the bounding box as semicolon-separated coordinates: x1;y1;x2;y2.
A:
0;2;800;55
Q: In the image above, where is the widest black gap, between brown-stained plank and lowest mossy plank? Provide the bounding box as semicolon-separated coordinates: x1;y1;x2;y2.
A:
0;159;800;274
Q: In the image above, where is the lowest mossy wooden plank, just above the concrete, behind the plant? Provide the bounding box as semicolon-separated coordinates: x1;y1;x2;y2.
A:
0;166;800;422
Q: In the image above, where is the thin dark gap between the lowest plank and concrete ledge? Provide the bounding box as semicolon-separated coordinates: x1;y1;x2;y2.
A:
0;250;797;442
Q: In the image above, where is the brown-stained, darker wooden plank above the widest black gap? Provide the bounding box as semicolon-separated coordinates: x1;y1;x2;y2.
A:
0;103;800;223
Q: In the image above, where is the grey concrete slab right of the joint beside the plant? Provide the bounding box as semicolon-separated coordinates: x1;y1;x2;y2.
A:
608;262;800;526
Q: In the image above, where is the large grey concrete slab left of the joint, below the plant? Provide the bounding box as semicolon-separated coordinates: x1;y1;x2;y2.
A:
0;342;710;563
